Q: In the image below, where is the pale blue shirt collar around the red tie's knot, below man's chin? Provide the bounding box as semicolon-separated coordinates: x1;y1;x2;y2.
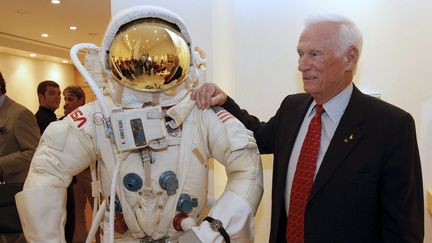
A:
307;83;353;124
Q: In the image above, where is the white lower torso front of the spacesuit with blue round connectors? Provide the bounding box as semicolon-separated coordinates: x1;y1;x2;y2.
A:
105;107;207;239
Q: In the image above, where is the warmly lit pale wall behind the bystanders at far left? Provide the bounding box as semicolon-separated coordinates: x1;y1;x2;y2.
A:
0;53;75;117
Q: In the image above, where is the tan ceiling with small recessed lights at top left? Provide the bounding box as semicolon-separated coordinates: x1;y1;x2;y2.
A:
0;0;111;61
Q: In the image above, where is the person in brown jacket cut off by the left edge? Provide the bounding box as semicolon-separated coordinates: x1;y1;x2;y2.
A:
0;72;40;243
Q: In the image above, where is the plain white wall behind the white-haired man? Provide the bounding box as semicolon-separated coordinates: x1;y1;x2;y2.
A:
226;0;432;243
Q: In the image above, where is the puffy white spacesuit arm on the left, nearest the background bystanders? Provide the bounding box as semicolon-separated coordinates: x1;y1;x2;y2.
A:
15;117;96;243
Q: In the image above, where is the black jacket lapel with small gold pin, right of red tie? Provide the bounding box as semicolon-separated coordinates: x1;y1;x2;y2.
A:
309;86;364;200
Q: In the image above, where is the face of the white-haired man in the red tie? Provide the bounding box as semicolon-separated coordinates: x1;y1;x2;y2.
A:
297;23;352;103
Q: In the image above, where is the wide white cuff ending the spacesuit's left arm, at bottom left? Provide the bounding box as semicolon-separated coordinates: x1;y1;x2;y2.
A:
15;188;66;243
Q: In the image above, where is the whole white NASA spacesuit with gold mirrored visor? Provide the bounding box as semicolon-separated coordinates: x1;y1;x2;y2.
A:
16;6;263;243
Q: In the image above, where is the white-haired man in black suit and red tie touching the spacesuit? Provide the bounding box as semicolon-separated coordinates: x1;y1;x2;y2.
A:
192;15;424;243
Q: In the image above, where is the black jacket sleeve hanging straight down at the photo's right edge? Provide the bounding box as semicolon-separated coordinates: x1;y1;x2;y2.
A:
381;113;424;243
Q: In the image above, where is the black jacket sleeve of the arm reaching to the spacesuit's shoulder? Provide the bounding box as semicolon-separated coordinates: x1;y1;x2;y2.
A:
223;97;282;154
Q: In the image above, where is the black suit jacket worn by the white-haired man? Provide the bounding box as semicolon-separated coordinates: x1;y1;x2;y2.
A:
224;87;424;243
